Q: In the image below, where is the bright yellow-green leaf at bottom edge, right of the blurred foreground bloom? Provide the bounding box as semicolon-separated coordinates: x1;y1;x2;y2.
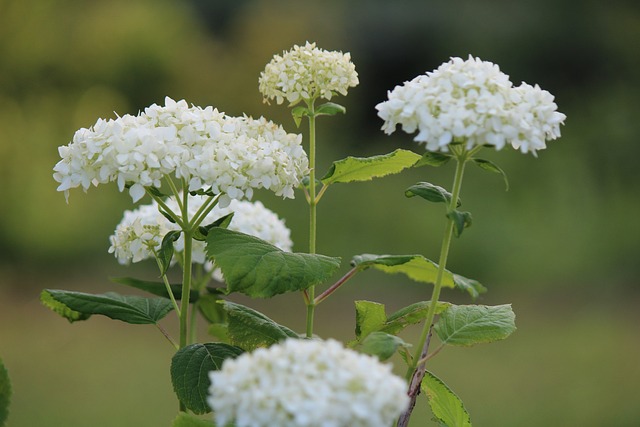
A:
420;371;471;427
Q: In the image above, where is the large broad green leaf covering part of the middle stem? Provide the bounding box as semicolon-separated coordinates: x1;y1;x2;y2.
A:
207;228;340;298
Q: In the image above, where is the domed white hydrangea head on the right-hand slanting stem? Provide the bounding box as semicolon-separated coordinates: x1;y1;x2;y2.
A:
376;56;566;154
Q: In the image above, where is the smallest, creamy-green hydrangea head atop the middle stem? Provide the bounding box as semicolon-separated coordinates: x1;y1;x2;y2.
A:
258;42;359;105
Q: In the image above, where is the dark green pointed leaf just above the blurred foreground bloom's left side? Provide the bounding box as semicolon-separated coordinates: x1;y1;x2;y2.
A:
223;301;299;351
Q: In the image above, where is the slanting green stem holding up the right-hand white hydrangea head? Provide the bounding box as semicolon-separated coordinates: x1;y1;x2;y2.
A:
398;147;472;427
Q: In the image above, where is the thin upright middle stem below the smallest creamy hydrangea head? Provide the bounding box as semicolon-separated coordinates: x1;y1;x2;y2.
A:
307;108;317;338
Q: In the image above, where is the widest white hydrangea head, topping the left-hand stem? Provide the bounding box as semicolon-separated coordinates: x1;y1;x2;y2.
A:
53;97;308;205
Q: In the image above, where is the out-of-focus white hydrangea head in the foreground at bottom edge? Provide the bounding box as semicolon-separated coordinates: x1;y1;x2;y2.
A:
208;338;409;427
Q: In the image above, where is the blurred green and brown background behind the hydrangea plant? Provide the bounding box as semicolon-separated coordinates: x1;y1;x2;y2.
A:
0;0;640;427
